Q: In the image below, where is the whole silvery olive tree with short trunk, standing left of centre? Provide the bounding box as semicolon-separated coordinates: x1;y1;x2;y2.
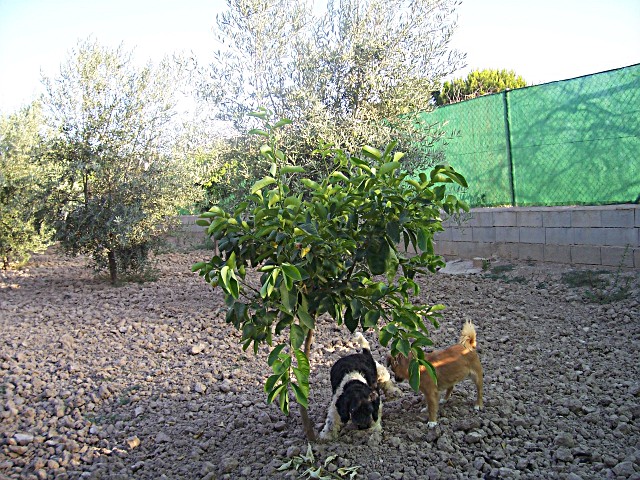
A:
43;40;198;283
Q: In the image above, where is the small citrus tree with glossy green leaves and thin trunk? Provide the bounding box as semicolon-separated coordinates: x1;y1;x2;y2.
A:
193;110;468;440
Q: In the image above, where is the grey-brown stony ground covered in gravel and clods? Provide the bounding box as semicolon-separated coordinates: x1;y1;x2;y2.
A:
0;251;640;480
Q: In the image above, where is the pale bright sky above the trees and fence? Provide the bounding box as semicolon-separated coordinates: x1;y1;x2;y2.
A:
0;0;640;114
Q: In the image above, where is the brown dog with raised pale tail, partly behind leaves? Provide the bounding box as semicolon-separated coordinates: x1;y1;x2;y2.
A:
387;321;482;427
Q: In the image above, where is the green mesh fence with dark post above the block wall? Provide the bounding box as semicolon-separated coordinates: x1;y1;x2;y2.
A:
425;64;640;206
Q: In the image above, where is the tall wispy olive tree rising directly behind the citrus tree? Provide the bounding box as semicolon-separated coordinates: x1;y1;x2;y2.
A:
200;0;463;199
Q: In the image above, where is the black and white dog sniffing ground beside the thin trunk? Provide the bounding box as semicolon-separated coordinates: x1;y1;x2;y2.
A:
320;333;400;440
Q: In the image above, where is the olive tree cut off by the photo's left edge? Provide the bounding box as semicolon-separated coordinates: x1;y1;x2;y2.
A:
0;103;51;269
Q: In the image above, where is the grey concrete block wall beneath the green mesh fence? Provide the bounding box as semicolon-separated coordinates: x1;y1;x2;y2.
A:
434;204;640;269
